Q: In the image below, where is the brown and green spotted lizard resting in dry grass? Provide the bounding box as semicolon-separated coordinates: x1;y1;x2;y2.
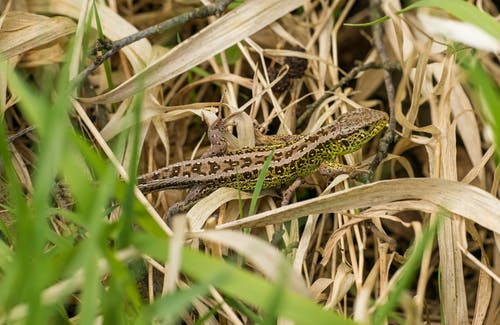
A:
137;108;388;219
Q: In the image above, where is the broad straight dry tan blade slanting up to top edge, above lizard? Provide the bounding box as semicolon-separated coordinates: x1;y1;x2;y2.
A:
82;0;305;103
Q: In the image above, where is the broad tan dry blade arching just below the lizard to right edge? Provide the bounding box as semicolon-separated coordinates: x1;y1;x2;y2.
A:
217;178;500;233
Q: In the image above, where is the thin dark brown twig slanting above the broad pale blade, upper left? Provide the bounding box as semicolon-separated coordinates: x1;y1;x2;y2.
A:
73;0;232;84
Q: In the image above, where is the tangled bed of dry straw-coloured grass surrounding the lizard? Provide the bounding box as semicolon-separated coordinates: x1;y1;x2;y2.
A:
0;0;500;324
